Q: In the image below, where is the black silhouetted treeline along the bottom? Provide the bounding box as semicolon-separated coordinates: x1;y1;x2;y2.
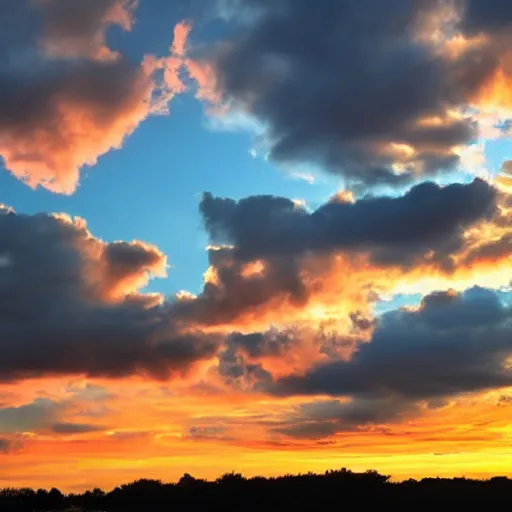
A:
0;469;512;512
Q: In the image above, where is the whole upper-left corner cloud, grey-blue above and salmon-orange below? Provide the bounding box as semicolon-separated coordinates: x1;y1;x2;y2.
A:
0;0;191;194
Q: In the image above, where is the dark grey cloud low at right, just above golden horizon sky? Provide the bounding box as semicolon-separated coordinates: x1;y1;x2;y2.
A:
271;288;512;431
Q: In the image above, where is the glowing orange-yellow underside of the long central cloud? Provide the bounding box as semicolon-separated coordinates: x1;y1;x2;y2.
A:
173;221;512;336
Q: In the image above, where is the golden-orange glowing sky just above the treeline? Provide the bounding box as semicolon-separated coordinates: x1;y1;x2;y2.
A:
2;379;512;491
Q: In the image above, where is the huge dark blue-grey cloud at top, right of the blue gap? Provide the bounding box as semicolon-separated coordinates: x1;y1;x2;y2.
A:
202;0;486;185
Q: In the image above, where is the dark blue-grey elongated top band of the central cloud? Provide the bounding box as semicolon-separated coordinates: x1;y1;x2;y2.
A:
201;179;496;265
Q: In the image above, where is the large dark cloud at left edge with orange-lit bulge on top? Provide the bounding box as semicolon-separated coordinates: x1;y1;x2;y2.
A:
0;204;219;380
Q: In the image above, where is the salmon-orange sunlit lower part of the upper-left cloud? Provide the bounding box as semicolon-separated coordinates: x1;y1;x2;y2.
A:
0;61;155;194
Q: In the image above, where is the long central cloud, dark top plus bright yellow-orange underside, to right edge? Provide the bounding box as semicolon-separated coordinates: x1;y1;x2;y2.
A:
167;179;511;334
